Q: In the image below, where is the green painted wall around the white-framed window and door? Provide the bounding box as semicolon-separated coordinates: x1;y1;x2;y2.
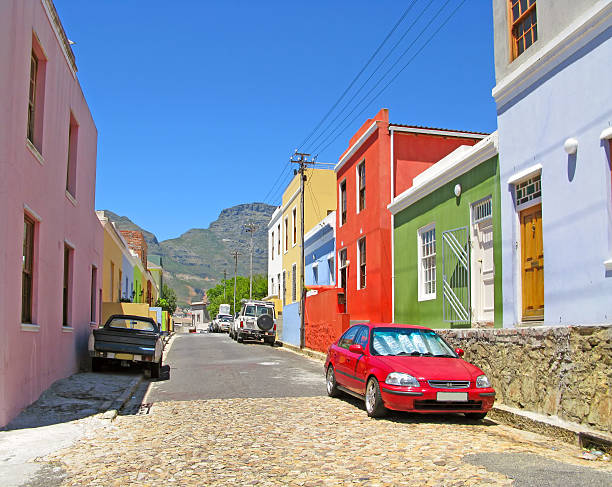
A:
394;157;502;328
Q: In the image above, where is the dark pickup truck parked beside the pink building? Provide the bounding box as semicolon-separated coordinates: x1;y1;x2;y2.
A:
88;315;163;378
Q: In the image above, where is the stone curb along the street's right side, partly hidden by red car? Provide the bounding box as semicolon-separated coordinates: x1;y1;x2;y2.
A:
276;341;612;450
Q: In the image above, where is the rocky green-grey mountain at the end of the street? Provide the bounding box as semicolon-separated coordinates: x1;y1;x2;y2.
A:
99;203;276;304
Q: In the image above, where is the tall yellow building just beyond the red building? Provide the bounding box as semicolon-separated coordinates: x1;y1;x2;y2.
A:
277;169;337;306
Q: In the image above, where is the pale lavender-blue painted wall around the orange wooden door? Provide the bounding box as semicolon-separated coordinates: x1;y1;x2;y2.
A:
494;8;612;327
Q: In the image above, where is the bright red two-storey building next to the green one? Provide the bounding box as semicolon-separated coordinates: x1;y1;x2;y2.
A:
335;109;487;322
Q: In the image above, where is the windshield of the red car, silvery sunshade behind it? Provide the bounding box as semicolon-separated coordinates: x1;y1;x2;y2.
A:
371;328;457;357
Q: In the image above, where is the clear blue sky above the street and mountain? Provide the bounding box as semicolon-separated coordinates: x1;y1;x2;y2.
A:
55;0;496;240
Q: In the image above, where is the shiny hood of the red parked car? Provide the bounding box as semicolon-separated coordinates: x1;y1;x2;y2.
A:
376;356;482;380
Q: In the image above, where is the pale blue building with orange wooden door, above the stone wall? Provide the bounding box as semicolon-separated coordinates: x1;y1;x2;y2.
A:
493;0;612;328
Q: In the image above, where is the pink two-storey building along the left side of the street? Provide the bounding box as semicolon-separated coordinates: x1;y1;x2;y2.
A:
0;0;103;426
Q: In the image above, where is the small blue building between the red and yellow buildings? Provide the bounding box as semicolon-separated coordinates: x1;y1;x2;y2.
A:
304;211;336;286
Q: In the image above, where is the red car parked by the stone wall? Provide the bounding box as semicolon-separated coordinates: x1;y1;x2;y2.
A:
325;323;495;419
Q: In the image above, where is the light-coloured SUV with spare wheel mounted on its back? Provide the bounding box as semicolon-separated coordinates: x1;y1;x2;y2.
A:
232;299;276;345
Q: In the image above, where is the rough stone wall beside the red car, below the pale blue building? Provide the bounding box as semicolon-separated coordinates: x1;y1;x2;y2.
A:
437;325;612;433
